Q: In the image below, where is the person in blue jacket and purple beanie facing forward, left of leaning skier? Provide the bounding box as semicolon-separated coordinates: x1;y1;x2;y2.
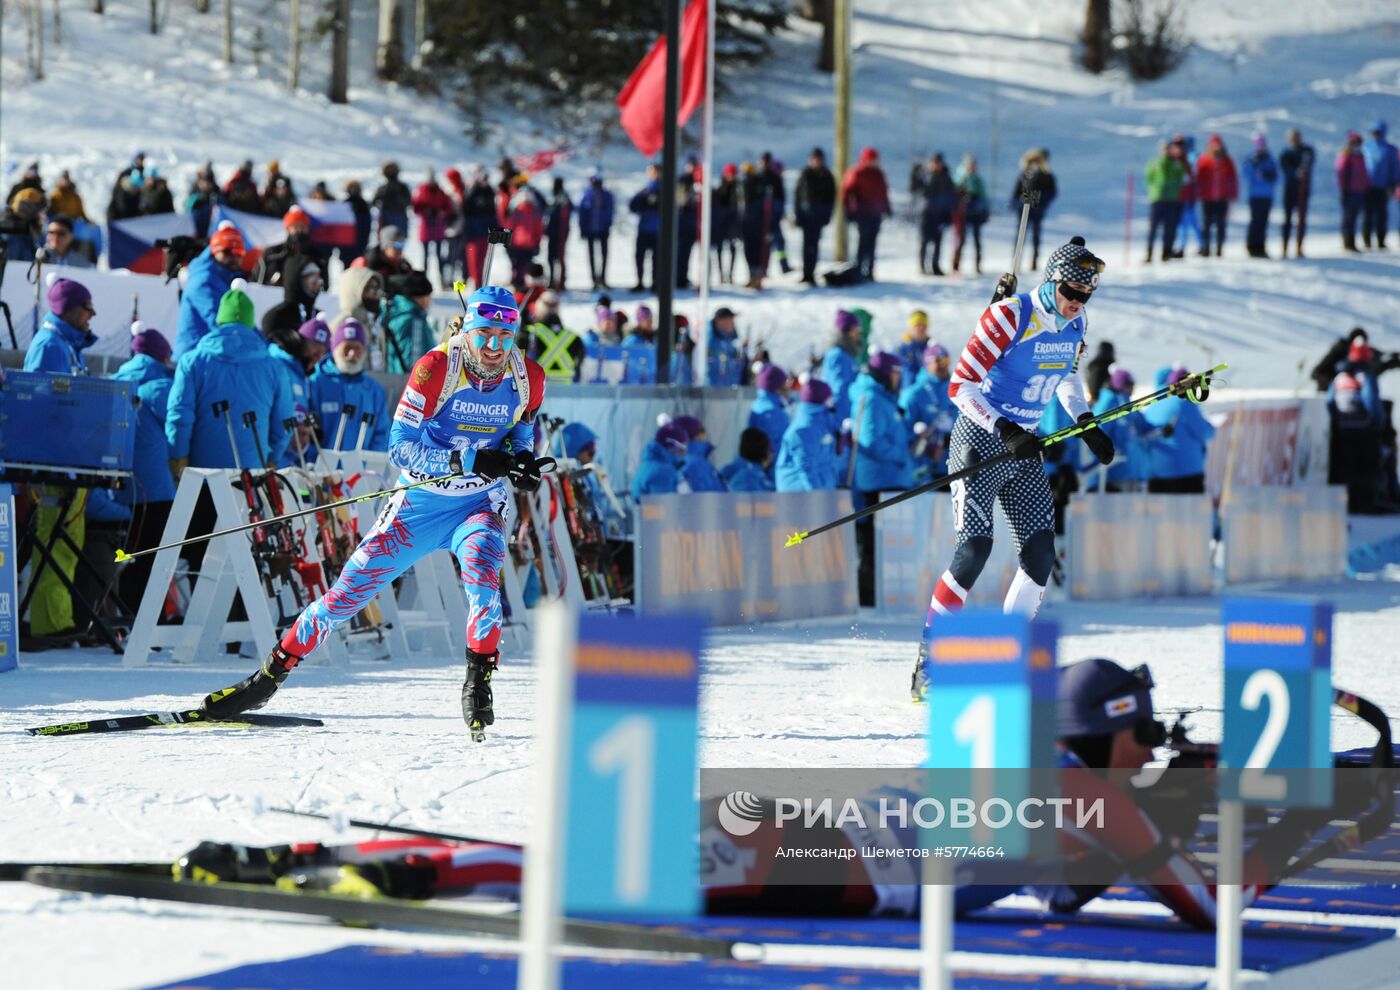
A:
311;318;389;451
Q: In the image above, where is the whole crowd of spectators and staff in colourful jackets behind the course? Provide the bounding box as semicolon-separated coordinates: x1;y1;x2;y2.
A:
3;120;1400;636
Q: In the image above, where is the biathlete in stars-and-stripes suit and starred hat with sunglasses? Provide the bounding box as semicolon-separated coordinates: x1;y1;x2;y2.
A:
910;237;1113;702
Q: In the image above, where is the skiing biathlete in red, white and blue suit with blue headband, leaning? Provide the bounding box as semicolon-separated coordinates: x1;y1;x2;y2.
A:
203;286;552;739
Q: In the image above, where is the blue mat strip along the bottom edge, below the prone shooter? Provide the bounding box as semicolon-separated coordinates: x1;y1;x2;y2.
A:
155;945;1205;990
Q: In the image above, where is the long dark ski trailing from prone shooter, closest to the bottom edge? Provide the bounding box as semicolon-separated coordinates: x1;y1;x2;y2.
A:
24;865;735;959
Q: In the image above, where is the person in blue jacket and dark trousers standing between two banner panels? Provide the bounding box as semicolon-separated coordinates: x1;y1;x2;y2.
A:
851;350;914;606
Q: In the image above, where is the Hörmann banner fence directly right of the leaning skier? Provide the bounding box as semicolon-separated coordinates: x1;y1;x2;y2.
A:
636;491;857;626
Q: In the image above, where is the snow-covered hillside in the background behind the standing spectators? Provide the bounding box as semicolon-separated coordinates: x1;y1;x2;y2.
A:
0;0;1400;388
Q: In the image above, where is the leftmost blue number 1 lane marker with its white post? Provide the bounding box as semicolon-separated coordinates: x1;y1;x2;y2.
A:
519;602;703;990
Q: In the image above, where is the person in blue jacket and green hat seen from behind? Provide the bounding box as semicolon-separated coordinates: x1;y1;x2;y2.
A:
165;279;293;480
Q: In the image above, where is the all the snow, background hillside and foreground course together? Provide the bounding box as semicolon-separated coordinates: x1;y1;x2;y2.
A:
0;0;1400;987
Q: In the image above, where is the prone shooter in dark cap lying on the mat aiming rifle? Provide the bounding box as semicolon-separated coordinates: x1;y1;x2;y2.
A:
175;658;1394;928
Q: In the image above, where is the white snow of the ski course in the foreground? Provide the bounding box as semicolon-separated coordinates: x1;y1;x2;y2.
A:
0;583;1400;987
